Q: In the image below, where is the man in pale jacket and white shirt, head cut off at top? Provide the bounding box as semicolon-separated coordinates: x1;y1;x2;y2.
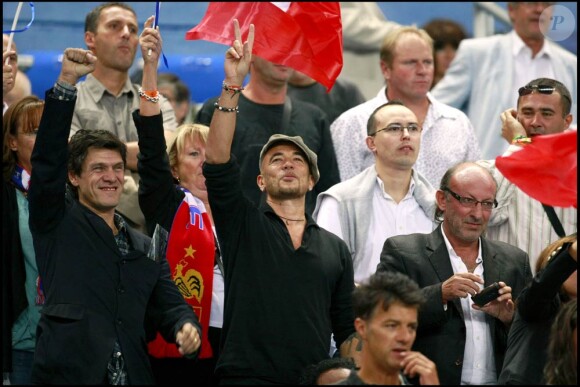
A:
432;2;578;160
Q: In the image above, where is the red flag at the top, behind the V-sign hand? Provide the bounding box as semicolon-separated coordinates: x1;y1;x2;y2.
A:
185;2;342;90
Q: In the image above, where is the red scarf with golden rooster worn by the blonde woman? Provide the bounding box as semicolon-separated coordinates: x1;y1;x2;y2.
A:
148;193;215;359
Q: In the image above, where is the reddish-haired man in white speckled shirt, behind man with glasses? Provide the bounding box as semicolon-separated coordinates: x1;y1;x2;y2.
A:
330;27;480;186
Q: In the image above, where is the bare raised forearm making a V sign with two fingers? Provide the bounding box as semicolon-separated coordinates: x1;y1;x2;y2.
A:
205;19;254;164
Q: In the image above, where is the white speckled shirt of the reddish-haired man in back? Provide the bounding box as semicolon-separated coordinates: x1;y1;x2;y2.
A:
330;87;481;187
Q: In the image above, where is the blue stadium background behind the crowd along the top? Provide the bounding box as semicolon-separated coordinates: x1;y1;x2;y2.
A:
2;2;578;103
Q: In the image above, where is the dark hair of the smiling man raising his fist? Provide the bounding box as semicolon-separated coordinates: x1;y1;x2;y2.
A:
67;129;127;194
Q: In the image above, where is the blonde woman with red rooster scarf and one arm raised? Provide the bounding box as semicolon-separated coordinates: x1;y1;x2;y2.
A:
133;16;224;385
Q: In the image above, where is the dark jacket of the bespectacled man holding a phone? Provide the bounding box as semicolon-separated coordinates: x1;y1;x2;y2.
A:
377;226;532;385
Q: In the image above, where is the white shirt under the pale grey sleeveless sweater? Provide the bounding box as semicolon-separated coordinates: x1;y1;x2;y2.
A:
316;177;435;283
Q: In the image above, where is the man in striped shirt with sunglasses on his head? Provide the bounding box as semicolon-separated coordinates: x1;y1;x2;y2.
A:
480;78;578;274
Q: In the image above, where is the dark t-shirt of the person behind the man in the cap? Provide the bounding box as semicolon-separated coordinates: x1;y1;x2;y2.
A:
197;94;340;214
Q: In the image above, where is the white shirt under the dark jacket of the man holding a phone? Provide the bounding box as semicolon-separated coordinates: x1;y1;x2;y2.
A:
441;227;497;385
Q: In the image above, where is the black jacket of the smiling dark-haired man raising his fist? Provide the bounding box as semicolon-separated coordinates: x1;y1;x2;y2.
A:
28;91;201;384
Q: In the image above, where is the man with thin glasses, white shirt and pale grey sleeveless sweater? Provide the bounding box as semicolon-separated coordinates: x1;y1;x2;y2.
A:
314;101;435;283
